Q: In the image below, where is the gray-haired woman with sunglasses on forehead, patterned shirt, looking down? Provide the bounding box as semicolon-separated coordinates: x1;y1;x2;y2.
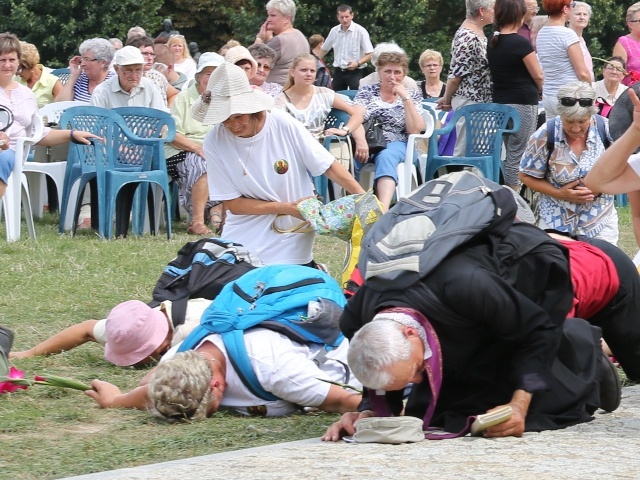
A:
520;82;618;245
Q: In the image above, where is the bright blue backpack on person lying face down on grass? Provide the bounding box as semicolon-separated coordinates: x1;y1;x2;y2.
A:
178;265;346;401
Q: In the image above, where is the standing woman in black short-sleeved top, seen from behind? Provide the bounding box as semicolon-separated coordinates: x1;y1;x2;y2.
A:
487;0;542;190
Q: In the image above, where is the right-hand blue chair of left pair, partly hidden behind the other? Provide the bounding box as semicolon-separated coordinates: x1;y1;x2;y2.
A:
113;107;178;235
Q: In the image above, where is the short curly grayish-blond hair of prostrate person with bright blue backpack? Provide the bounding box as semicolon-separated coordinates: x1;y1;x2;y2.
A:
148;350;213;422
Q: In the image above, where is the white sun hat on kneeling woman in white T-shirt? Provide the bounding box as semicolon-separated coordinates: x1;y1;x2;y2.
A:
198;62;273;125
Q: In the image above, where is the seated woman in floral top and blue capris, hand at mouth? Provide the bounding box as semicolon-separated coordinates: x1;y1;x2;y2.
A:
353;52;426;210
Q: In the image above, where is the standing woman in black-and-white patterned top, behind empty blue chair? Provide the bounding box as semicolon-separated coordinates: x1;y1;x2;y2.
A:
436;0;495;157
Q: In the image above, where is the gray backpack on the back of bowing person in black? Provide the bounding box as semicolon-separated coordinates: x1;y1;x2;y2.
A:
358;170;517;291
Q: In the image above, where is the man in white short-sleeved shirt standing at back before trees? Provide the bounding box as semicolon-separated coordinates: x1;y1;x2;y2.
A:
319;5;373;91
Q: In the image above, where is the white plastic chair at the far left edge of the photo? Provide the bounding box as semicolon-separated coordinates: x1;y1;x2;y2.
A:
2;113;44;242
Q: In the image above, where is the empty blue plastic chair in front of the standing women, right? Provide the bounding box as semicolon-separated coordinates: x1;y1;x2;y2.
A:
425;103;520;182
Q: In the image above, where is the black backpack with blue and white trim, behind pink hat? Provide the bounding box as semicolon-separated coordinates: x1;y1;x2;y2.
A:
148;238;262;326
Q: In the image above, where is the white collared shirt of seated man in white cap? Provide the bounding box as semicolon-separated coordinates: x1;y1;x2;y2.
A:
91;75;169;112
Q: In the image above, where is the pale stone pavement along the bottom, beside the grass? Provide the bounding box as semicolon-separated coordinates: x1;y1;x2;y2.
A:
67;385;640;480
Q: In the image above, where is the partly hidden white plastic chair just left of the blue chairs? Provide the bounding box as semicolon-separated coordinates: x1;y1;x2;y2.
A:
23;101;87;223
